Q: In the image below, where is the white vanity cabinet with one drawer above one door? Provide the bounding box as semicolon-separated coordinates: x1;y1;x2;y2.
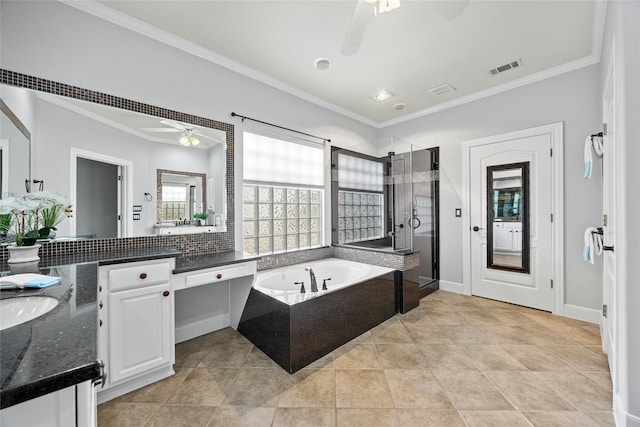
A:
98;258;175;402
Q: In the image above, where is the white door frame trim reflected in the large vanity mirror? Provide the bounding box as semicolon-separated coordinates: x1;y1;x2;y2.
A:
69;147;133;237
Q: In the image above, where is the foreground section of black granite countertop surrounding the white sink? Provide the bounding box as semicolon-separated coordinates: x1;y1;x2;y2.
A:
0;263;100;408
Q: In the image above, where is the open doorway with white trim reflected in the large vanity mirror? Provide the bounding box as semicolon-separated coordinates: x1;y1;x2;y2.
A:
69;148;133;239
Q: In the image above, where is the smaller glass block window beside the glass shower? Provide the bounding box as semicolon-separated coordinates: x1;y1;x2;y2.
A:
338;190;384;243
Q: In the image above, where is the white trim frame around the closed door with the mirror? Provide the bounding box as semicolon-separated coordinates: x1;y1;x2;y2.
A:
462;122;564;315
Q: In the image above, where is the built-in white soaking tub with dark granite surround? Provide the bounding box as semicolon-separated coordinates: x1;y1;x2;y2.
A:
238;258;396;373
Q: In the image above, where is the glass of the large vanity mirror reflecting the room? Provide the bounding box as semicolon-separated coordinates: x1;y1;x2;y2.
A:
0;77;233;238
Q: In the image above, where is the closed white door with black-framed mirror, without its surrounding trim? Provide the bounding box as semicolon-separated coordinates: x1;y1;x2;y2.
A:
468;132;554;311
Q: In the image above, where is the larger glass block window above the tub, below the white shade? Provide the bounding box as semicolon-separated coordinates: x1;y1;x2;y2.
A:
242;184;323;255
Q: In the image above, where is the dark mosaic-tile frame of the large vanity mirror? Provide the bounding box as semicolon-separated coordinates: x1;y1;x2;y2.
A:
0;68;235;247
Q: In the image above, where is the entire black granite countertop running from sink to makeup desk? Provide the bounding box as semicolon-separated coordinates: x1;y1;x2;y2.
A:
0;248;259;409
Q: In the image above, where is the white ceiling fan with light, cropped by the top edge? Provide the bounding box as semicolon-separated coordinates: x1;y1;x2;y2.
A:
340;0;469;56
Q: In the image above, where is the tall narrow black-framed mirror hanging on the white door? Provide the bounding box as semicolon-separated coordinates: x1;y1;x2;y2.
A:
487;162;530;273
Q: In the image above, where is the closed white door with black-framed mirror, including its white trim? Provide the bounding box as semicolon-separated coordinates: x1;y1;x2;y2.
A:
463;123;563;312
